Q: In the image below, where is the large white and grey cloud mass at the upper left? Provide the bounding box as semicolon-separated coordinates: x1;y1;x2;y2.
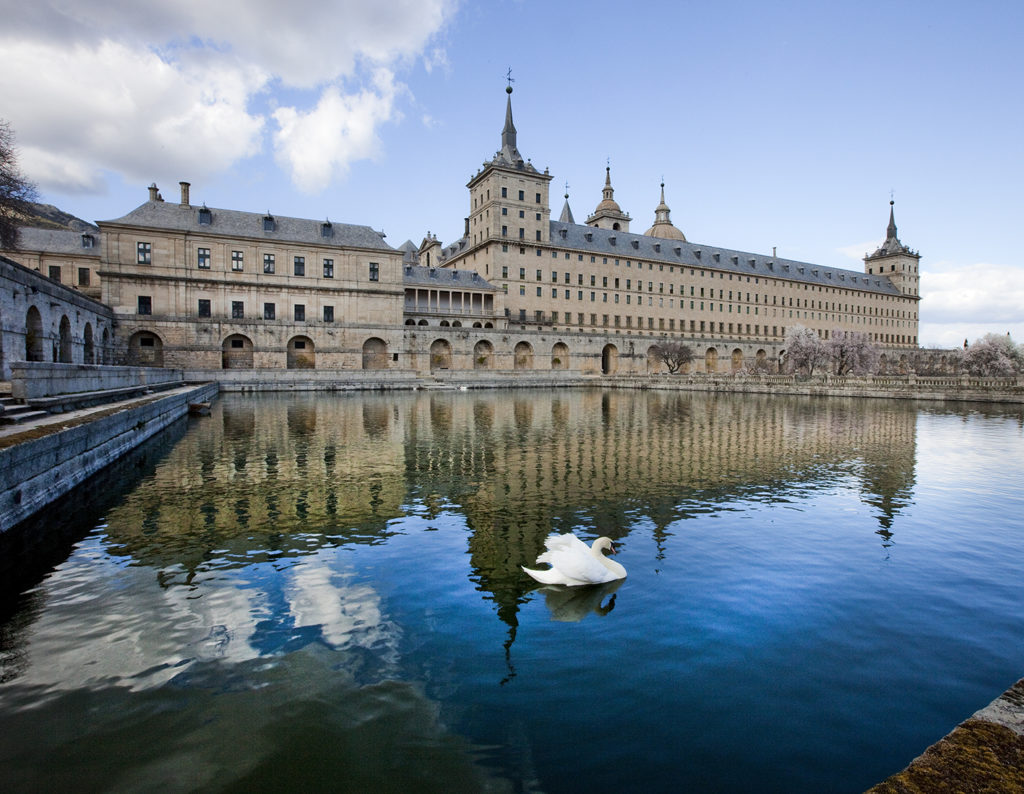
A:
0;0;452;192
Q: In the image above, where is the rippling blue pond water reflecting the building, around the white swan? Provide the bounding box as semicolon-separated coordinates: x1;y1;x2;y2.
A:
0;390;1024;792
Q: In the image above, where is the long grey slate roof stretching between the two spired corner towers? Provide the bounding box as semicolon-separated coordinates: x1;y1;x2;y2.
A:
544;220;901;295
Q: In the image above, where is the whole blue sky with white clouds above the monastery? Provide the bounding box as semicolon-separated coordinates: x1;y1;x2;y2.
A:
0;0;1024;347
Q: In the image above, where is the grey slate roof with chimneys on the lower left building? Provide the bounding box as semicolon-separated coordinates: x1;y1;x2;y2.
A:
99;201;394;251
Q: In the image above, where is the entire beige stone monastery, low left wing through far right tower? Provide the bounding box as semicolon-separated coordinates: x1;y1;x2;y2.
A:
2;88;920;374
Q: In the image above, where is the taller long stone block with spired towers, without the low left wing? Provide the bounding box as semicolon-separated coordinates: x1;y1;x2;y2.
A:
432;88;920;363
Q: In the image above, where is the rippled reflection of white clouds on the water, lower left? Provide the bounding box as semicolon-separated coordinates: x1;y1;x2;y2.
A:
11;538;397;689
